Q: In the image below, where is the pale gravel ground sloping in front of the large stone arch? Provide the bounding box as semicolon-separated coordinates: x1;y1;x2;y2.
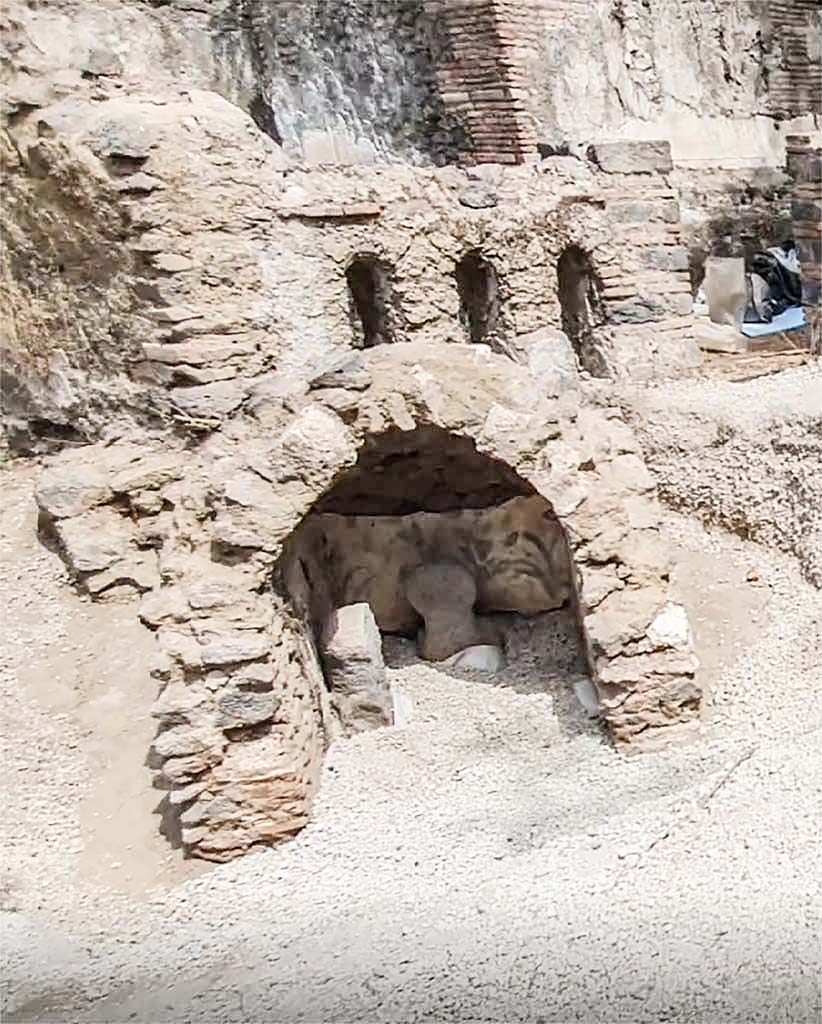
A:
0;467;822;1024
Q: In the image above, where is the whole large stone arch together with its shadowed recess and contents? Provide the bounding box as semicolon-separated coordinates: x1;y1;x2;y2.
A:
38;342;700;859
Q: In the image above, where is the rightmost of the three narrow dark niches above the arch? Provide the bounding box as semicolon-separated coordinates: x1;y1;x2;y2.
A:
557;245;607;377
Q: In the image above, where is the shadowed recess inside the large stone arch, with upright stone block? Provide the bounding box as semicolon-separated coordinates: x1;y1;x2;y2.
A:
278;425;594;732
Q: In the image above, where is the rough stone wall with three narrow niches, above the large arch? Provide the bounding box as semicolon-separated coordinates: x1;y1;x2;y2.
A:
7;90;698;437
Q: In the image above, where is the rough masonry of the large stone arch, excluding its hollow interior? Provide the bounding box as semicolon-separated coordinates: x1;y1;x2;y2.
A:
38;342;700;859
